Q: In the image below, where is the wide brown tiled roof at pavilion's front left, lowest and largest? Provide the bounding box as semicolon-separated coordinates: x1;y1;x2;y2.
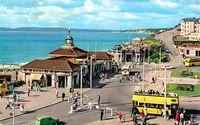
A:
21;60;80;72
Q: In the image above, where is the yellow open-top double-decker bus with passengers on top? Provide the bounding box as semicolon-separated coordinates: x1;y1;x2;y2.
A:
132;93;179;117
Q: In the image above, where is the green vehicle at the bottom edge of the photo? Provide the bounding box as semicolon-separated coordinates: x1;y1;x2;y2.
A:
35;116;59;125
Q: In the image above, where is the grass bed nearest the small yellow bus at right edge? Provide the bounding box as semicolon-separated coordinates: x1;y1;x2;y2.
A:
171;70;200;78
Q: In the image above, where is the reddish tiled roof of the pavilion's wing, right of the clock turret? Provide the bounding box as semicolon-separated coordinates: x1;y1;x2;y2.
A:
88;52;112;59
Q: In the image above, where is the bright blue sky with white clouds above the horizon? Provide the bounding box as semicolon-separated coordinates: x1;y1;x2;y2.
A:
0;0;200;30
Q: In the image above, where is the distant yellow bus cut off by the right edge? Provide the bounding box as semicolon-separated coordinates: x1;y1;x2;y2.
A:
183;58;200;66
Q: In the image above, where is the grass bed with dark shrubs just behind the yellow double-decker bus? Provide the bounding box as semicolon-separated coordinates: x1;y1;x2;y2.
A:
167;83;200;96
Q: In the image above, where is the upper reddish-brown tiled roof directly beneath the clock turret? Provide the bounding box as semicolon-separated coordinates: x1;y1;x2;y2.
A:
49;47;87;57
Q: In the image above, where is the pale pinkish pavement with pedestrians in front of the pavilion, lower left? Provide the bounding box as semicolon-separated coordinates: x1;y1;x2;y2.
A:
0;85;89;120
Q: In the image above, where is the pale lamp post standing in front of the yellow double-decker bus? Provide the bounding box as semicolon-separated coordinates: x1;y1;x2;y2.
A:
164;66;167;119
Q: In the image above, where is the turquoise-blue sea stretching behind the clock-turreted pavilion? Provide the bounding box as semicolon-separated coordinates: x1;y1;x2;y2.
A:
0;31;149;65
